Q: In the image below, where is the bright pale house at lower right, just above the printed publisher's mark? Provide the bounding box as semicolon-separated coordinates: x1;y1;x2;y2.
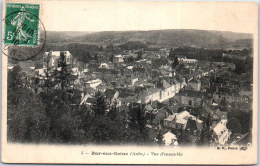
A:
212;120;231;145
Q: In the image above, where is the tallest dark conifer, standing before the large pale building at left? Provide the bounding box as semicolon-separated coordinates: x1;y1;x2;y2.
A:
40;52;79;142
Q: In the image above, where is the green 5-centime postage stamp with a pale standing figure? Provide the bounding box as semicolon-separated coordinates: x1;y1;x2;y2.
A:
4;3;40;46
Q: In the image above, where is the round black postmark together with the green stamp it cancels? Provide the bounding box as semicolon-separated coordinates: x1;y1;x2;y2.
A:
2;3;46;61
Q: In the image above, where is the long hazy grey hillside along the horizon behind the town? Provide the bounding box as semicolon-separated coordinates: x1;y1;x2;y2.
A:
44;30;253;49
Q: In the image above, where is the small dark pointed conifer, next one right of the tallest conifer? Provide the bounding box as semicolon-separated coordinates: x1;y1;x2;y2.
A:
91;91;108;116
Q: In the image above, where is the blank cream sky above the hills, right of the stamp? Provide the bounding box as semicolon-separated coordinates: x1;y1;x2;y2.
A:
29;0;258;33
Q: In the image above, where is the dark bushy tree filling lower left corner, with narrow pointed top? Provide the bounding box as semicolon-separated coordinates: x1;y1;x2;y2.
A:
7;72;49;142
